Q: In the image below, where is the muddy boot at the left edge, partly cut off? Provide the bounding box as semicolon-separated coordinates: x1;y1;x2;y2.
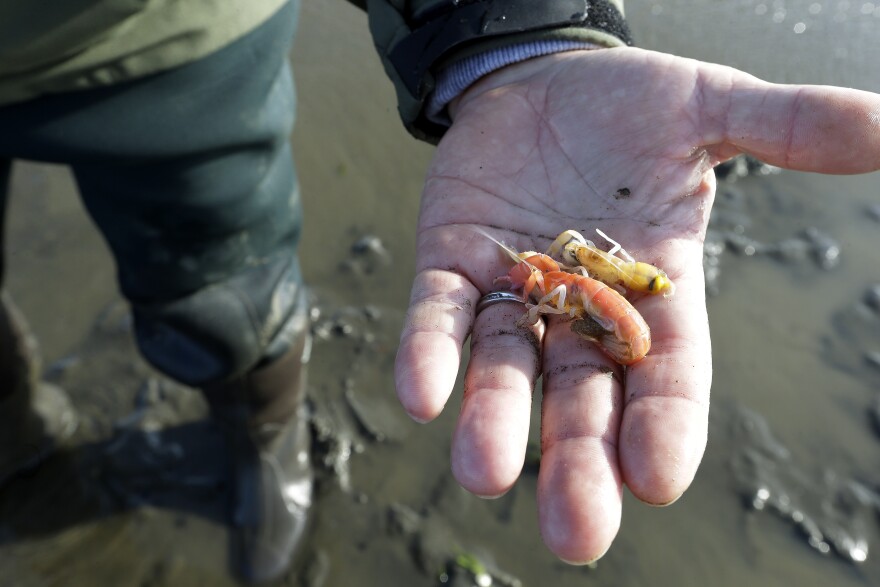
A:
0;293;78;487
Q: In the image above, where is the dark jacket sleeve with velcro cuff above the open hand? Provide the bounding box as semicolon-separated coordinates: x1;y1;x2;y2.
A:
350;0;632;143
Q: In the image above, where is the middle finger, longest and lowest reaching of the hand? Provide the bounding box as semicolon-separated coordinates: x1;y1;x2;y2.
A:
538;321;622;564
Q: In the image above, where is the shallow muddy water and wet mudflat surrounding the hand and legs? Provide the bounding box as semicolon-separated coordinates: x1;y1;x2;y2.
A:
0;0;880;587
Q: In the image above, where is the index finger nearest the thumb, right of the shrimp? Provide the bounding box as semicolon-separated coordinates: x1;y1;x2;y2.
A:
619;241;712;505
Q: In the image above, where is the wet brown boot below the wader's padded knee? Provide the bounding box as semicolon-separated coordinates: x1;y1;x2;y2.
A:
204;325;313;582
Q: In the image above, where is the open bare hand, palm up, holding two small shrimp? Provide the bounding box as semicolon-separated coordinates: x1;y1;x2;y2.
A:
397;50;880;562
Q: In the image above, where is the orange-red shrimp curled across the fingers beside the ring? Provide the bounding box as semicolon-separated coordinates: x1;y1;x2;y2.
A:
496;253;651;365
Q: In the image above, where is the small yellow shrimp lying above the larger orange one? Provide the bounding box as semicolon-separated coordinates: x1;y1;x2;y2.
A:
547;228;675;297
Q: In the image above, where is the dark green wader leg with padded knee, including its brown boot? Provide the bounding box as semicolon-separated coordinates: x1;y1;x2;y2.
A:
0;1;311;579
